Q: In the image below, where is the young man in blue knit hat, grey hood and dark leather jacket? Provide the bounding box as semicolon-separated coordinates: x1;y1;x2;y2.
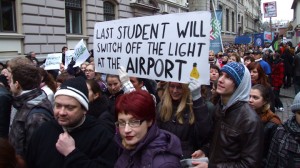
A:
194;62;263;168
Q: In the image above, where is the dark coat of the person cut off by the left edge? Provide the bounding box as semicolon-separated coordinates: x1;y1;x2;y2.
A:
0;85;12;138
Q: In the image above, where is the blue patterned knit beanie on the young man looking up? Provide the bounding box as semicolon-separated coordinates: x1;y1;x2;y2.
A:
221;62;245;87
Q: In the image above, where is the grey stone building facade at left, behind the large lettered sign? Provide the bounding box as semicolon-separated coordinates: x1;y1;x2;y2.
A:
0;0;188;62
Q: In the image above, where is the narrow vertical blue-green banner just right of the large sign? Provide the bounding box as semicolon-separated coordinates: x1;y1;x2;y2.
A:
209;10;222;53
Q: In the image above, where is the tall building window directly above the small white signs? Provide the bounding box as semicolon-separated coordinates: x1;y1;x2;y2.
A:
65;0;82;34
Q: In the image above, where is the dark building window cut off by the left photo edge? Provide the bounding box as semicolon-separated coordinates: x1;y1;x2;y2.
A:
0;0;17;32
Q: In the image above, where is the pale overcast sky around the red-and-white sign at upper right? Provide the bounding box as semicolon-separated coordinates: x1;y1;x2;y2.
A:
261;0;294;21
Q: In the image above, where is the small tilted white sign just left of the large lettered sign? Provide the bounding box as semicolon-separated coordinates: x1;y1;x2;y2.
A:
65;39;90;69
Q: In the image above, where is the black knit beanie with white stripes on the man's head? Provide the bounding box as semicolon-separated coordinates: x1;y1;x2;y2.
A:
54;77;89;110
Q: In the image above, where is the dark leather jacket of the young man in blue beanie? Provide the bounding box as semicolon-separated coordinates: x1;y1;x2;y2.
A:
208;101;264;168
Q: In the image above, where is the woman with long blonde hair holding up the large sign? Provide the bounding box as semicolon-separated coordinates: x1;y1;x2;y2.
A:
157;79;212;158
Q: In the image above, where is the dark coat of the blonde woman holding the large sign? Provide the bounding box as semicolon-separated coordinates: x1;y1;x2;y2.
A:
157;98;213;158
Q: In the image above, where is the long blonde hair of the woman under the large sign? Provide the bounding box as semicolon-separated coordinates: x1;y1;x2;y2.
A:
159;82;195;124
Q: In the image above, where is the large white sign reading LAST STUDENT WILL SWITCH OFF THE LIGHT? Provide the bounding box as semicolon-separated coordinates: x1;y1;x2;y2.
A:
93;11;211;84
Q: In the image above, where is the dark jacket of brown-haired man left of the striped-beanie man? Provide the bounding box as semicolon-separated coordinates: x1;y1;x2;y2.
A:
9;88;53;156
